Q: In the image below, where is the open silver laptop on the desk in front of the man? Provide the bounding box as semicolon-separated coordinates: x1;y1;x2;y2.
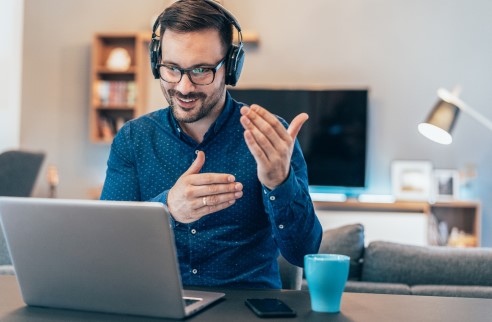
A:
0;197;225;319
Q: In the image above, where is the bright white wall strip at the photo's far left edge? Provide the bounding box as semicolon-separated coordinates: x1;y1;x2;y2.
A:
0;0;24;153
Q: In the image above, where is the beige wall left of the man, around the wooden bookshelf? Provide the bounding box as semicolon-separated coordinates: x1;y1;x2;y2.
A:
21;0;167;198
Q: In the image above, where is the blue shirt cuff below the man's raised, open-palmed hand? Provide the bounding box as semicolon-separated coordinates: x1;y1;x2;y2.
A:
262;166;298;209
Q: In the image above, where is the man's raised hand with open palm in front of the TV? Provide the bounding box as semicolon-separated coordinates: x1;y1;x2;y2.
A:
241;104;309;190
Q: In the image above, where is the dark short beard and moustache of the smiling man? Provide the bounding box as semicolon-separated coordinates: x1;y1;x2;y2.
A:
162;80;225;123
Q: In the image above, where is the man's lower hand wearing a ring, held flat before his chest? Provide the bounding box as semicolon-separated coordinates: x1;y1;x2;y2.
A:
167;151;243;223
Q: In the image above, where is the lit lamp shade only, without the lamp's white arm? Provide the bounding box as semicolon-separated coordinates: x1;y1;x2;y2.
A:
418;99;460;144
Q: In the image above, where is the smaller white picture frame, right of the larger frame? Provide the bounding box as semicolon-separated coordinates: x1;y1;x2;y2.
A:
432;169;460;201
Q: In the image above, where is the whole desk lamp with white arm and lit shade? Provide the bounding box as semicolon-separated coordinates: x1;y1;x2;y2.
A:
418;87;492;144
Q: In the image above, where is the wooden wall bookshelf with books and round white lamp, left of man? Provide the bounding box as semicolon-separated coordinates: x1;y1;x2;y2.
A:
89;33;150;142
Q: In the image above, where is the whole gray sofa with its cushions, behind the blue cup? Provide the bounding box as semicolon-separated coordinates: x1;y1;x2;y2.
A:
301;224;492;298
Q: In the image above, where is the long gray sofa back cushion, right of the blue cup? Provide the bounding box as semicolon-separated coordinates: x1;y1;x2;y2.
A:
362;241;492;286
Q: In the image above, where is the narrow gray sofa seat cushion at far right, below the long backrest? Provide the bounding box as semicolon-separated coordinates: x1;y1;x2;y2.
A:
410;285;492;299
